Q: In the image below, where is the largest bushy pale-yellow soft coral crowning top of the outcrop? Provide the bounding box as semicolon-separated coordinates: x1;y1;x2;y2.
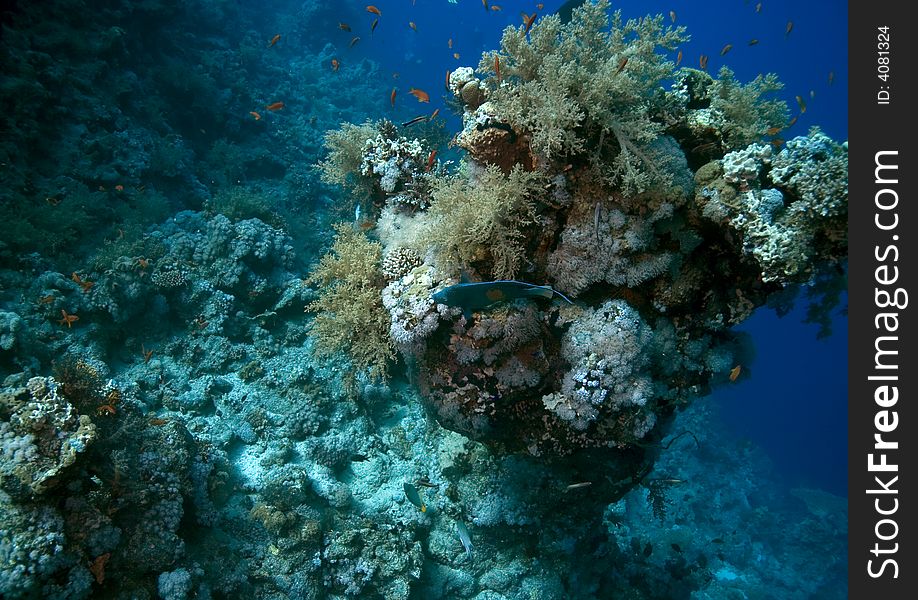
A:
479;0;687;193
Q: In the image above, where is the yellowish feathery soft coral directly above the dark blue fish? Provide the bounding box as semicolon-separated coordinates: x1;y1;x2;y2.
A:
424;165;544;279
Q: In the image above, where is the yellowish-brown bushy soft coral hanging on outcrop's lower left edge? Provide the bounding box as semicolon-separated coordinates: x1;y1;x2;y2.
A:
306;223;394;386
